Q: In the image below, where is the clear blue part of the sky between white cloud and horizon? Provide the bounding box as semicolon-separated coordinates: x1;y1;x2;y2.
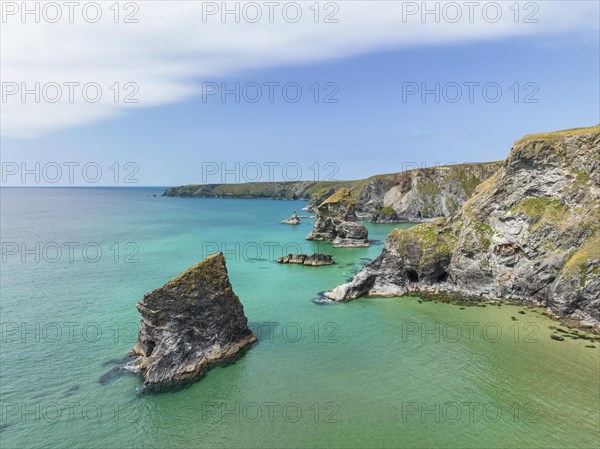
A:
1;1;600;185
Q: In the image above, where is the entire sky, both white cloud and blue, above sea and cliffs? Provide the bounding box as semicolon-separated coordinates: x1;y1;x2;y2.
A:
0;1;600;186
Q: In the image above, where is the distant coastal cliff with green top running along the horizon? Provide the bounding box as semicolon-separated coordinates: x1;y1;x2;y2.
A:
164;162;501;223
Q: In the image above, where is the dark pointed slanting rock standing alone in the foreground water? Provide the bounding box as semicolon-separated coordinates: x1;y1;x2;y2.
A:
133;252;256;388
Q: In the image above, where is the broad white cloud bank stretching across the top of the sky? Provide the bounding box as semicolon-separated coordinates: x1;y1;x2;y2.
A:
0;1;598;137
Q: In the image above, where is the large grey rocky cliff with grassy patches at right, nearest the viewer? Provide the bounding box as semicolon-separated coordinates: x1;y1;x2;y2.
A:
326;126;600;326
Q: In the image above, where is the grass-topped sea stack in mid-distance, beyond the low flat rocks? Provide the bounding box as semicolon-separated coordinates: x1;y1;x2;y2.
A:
306;189;369;248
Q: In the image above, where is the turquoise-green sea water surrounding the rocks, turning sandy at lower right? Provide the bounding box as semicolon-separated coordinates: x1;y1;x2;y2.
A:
0;188;600;448
